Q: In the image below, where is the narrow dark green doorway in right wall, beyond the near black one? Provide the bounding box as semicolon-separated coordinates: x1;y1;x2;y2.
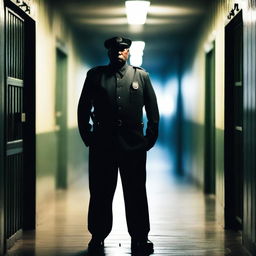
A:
204;43;215;194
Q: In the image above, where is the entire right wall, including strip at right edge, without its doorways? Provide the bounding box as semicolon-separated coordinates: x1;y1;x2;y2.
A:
182;0;256;253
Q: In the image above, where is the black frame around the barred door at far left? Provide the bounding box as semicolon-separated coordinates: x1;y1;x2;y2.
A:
0;0;36;252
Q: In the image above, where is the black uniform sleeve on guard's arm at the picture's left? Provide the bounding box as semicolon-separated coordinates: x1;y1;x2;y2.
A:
77;70;93;146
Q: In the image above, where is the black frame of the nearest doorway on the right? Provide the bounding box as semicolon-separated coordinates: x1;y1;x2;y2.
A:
224;10;244;230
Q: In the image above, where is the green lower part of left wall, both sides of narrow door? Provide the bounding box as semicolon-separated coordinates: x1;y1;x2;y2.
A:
36;128;88;209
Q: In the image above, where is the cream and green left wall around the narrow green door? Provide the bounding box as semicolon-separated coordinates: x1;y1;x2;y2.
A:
34;0;86;212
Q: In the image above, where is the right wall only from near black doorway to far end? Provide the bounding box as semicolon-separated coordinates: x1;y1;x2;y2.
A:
182;1;227;220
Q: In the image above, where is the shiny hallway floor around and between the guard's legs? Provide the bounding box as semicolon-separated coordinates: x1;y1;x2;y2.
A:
7;147;248;256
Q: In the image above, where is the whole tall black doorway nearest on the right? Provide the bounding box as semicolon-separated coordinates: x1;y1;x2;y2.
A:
224;11;244;229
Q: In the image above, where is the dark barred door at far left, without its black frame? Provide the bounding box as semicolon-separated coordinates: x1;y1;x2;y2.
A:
5;8;25;247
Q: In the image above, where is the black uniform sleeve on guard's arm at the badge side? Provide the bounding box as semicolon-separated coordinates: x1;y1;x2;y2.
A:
144;73;159;150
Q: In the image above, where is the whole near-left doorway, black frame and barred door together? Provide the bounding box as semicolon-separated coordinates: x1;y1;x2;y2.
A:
4;1;35;252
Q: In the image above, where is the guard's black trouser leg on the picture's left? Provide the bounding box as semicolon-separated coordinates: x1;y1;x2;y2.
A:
88;148;118;239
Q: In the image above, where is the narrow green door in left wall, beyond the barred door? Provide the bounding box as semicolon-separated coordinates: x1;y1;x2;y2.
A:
55;47;67;188
